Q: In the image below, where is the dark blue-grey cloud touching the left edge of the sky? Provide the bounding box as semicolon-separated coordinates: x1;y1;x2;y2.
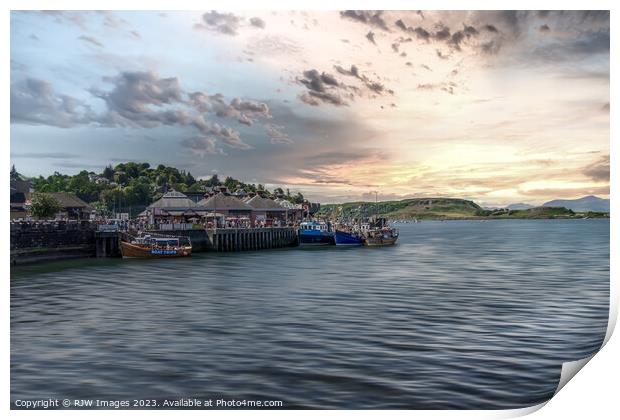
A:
11;78;93;128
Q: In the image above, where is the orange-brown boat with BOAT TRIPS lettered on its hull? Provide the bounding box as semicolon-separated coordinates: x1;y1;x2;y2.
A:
121;235;192;258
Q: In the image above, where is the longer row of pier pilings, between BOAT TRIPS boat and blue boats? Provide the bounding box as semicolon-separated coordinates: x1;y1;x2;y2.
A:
207;228;297;252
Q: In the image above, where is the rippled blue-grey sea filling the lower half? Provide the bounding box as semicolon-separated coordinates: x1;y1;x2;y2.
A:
11;220;609;409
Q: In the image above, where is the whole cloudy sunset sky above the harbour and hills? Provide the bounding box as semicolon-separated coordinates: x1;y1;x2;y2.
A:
10;10;610;206
